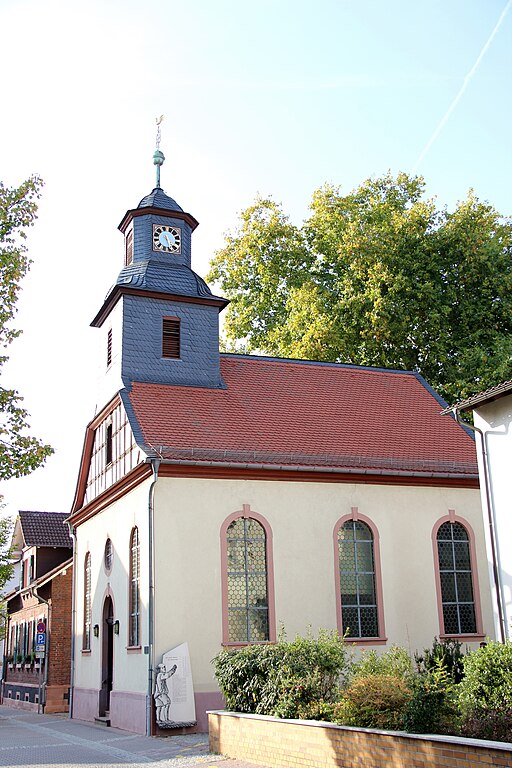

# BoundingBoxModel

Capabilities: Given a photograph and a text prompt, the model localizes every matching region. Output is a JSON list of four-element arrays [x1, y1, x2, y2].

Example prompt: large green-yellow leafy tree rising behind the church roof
[[207, 173, 512, 401]]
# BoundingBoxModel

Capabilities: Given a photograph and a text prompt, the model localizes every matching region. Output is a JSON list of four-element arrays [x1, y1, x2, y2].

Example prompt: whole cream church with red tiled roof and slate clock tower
[[70, 152, 493, 733]]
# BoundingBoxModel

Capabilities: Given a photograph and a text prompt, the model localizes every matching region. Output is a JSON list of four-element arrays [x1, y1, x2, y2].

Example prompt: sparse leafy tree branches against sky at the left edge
[[0, 176, 53, 480]]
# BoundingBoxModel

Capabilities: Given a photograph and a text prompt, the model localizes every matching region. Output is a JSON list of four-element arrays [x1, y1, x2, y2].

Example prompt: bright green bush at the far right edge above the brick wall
[[458, 642, 512, 741]]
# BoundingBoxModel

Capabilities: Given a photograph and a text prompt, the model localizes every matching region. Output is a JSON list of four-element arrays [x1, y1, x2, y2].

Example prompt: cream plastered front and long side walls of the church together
[[74, 477, 494, 733]]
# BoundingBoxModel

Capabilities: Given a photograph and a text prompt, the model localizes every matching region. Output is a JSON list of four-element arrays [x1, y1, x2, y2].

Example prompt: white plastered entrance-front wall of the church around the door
[[75, 481, 150, 693]]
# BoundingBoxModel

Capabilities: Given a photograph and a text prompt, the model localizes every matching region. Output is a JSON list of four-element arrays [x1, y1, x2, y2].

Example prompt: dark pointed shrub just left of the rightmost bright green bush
[[402, 657, 458, 734]]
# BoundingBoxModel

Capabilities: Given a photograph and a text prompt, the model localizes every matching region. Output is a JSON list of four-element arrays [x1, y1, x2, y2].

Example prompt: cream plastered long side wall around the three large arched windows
[[151, 478, 494, 692]]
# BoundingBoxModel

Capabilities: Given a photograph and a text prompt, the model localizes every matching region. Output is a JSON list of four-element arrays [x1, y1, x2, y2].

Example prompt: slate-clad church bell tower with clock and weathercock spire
[[91, 121, 228, 402]]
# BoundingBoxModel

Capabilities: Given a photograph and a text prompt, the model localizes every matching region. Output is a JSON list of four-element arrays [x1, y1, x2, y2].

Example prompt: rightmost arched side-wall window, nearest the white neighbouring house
[[434, 512, 481, 637]]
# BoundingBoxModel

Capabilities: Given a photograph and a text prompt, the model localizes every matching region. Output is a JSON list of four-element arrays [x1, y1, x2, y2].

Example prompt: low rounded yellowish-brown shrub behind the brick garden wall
[[335, 674, 411, 730]]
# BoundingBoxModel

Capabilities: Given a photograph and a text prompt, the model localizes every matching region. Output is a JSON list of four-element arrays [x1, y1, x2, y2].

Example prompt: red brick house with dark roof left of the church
[[2, 511, 73, 712]]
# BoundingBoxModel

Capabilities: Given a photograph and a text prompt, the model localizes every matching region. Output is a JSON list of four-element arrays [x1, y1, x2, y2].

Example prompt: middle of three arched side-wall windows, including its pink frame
[[334, 508, 385, 642]]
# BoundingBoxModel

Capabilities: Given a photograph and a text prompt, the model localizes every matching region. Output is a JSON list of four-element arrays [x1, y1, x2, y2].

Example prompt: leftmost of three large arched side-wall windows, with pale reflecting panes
[[221, 505, 275, 645]]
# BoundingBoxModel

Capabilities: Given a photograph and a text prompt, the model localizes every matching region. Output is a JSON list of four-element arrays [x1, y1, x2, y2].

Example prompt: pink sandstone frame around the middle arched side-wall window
[[333, 507, 387, 645]]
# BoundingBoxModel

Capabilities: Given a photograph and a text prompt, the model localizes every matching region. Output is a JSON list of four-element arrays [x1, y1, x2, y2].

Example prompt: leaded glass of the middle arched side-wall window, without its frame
[[338, 520, 379, 637]]
